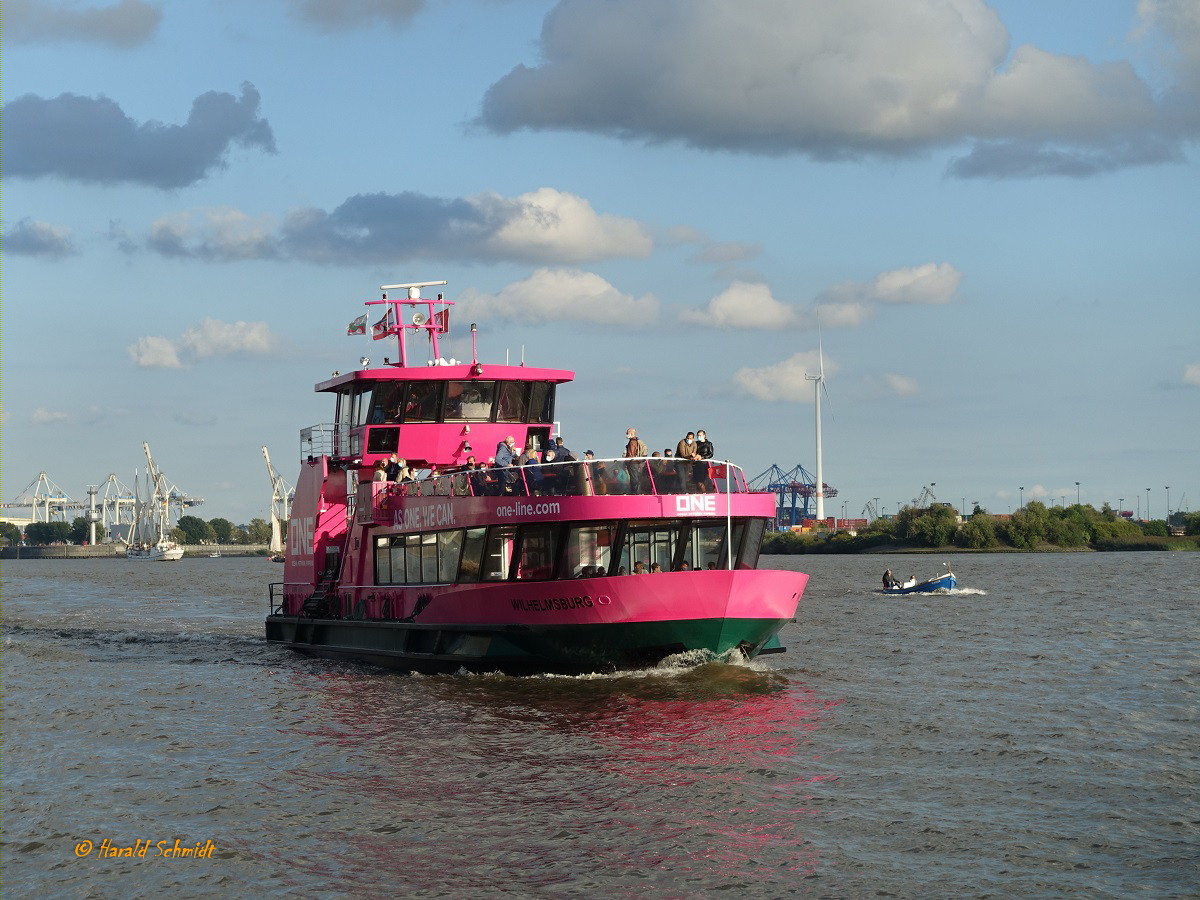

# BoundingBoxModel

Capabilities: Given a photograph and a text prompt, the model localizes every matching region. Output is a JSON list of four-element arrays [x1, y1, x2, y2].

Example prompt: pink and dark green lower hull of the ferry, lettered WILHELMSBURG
[[266, 570, 806, 674]]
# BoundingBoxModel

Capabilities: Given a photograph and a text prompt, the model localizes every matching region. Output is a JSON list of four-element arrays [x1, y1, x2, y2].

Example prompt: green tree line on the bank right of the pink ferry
[[762, 500, 1200, 553]]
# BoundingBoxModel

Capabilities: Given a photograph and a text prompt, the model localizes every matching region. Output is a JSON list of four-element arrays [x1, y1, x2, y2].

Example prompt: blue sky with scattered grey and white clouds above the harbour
[[0, 0, 1200, 522]]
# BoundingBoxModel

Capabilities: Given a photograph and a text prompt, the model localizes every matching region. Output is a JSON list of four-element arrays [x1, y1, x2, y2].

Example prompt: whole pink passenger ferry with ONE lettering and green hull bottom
[[266, 281, 808, 674]]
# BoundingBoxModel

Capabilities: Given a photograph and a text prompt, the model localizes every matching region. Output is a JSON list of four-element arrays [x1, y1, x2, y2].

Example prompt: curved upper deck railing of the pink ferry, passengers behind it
[[355, 457, 751, 524]]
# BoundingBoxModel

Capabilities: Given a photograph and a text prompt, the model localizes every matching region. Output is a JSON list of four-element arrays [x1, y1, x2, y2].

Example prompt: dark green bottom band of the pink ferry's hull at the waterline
[[266, 616, 790, 674]]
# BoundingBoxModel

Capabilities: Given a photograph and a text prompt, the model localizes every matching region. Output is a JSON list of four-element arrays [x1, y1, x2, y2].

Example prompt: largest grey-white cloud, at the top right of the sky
[[480, 0, 1200, 176]]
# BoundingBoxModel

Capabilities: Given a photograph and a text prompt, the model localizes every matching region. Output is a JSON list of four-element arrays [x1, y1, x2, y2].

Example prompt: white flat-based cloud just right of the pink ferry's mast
[[455, 269, 659, 328]]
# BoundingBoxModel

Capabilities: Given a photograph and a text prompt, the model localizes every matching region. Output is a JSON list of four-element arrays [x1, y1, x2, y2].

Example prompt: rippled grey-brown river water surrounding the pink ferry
[[2, 553, 1200, 898]]
